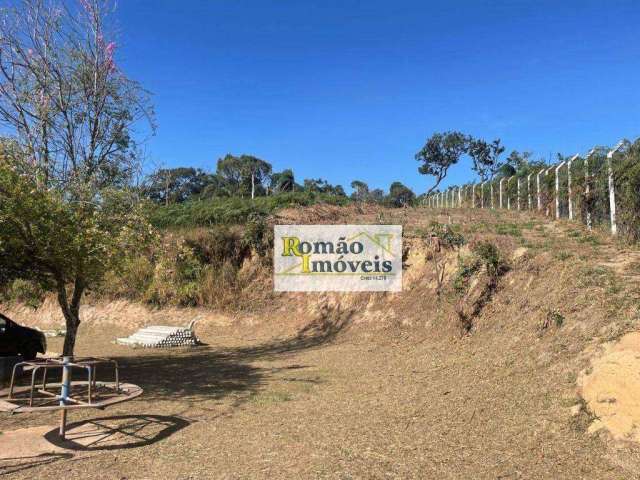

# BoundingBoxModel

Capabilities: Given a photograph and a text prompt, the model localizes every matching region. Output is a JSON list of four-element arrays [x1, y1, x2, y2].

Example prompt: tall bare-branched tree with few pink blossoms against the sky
[[0, 0, 153, 191]]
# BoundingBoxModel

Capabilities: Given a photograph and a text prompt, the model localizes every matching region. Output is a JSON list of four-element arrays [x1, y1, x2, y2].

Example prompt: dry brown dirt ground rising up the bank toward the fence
[[0, 207, 640, 480]]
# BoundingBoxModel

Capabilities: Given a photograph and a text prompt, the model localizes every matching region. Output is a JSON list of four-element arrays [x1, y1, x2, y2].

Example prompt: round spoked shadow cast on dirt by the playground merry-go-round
[[45, 415, 191, 452]]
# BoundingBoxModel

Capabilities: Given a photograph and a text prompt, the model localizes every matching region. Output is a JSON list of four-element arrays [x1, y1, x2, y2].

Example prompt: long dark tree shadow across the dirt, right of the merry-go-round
[[107, 311, 352, 405]]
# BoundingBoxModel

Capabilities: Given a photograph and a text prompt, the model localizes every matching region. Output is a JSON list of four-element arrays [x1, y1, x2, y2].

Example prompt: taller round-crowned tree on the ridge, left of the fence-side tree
[[415, 132, 469, 194]]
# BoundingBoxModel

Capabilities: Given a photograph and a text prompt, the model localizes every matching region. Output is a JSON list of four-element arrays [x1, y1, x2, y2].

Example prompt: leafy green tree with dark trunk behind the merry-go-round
[[0, 156, 154, 355]]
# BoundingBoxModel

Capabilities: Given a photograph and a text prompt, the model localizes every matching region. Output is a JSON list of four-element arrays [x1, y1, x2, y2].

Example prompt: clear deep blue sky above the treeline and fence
[[116, 0, 640, 193]]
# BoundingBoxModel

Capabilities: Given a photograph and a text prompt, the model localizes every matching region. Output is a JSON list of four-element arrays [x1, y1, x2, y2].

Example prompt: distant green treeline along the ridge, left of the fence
[[139, 155, 416, 228]]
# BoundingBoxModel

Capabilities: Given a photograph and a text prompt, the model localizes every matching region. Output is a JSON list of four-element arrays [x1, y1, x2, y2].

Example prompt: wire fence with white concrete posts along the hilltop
[[423, 139, 640, 241]]
